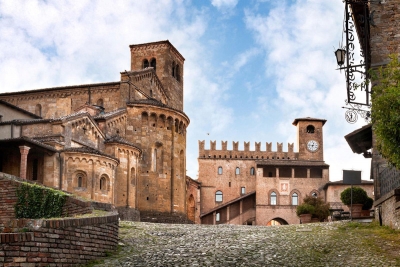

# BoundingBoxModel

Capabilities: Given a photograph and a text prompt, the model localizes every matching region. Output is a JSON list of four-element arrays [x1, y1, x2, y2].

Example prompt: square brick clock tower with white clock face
[[293, 117, 326, 161]]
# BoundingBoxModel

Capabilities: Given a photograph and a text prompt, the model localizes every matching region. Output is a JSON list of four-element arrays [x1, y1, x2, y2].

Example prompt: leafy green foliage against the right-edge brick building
[[371, 54, 400, 168]]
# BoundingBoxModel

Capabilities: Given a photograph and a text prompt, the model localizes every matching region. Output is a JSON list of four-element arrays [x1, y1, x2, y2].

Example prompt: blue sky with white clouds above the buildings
[[0, 0, 370, 181]]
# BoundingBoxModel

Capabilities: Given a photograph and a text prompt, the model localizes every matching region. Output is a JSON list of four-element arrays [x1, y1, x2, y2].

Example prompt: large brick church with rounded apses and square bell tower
[[0, 41, 189, 221]]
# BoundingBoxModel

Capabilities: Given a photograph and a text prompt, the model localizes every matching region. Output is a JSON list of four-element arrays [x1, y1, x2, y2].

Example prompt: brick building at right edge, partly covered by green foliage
[[345, 0, 400, 229]]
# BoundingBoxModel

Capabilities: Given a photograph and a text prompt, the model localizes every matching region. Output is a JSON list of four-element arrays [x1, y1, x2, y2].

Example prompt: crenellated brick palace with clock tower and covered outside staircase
[[198, 117, 329, 225]]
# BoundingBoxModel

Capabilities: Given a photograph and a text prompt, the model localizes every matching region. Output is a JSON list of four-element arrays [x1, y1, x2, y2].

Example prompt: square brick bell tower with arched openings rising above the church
[[129, 40, 185, 111]]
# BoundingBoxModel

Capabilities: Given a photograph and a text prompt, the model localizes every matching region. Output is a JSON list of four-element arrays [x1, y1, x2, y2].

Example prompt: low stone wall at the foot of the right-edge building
[[374, 189, 400, 230]]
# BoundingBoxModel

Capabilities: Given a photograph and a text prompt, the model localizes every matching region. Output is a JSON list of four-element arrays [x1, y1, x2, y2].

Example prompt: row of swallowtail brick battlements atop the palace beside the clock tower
[[199, 140, 298, 160]]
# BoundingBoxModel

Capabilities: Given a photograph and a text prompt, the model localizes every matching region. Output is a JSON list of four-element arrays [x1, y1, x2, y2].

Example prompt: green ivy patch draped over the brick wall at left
[[15, 183, 67, 219]]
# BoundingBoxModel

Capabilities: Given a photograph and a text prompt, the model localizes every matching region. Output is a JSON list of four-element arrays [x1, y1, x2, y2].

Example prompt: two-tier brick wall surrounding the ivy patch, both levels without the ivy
[[0, 173, 118, 266]]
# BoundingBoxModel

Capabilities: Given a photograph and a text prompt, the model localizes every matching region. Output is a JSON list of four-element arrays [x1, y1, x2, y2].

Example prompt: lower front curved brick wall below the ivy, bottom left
[[0, 212, 118, 266]]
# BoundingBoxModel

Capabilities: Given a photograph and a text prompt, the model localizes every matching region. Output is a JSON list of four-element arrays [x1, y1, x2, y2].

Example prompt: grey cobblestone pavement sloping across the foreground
[[95, 222, 399, 267]]
